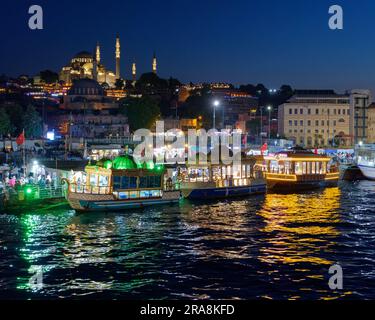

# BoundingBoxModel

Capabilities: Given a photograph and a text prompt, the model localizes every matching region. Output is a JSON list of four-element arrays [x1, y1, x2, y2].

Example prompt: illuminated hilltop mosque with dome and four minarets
[[59, 36, 157, 87]]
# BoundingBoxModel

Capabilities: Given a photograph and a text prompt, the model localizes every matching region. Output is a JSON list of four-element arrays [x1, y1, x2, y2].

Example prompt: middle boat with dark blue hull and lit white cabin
[[178, 155, 267, 200]]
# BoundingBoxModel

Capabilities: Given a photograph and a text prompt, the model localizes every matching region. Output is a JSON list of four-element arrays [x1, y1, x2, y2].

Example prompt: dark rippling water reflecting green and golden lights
[[0, 181, 375, 299]]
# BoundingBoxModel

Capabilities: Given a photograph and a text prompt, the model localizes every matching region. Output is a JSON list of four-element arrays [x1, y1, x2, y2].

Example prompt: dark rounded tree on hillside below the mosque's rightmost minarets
[[120, 96, 160, 132]]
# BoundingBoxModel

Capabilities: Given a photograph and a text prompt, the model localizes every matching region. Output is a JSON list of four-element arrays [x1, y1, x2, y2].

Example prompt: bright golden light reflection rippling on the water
[[258, 188, 341, 265]]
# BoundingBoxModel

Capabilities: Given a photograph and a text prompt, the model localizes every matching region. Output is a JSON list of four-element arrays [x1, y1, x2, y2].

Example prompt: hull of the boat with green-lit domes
[[68, 191, 181, 212]]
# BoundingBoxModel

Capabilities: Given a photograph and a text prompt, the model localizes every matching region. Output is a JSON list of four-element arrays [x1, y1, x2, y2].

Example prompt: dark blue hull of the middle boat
[[182, 183, 267, 200]]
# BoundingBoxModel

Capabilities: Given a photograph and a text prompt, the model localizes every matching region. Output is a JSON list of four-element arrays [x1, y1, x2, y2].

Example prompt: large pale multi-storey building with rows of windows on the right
[[278, 90, 353, 147]]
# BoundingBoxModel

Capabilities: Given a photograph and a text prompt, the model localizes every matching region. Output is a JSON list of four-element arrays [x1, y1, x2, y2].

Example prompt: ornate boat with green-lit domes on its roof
[[66, 156, 181, 211]]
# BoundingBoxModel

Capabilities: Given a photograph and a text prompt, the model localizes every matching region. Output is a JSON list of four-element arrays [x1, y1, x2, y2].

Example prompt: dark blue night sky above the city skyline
[[0, 0, 375, 91]]
